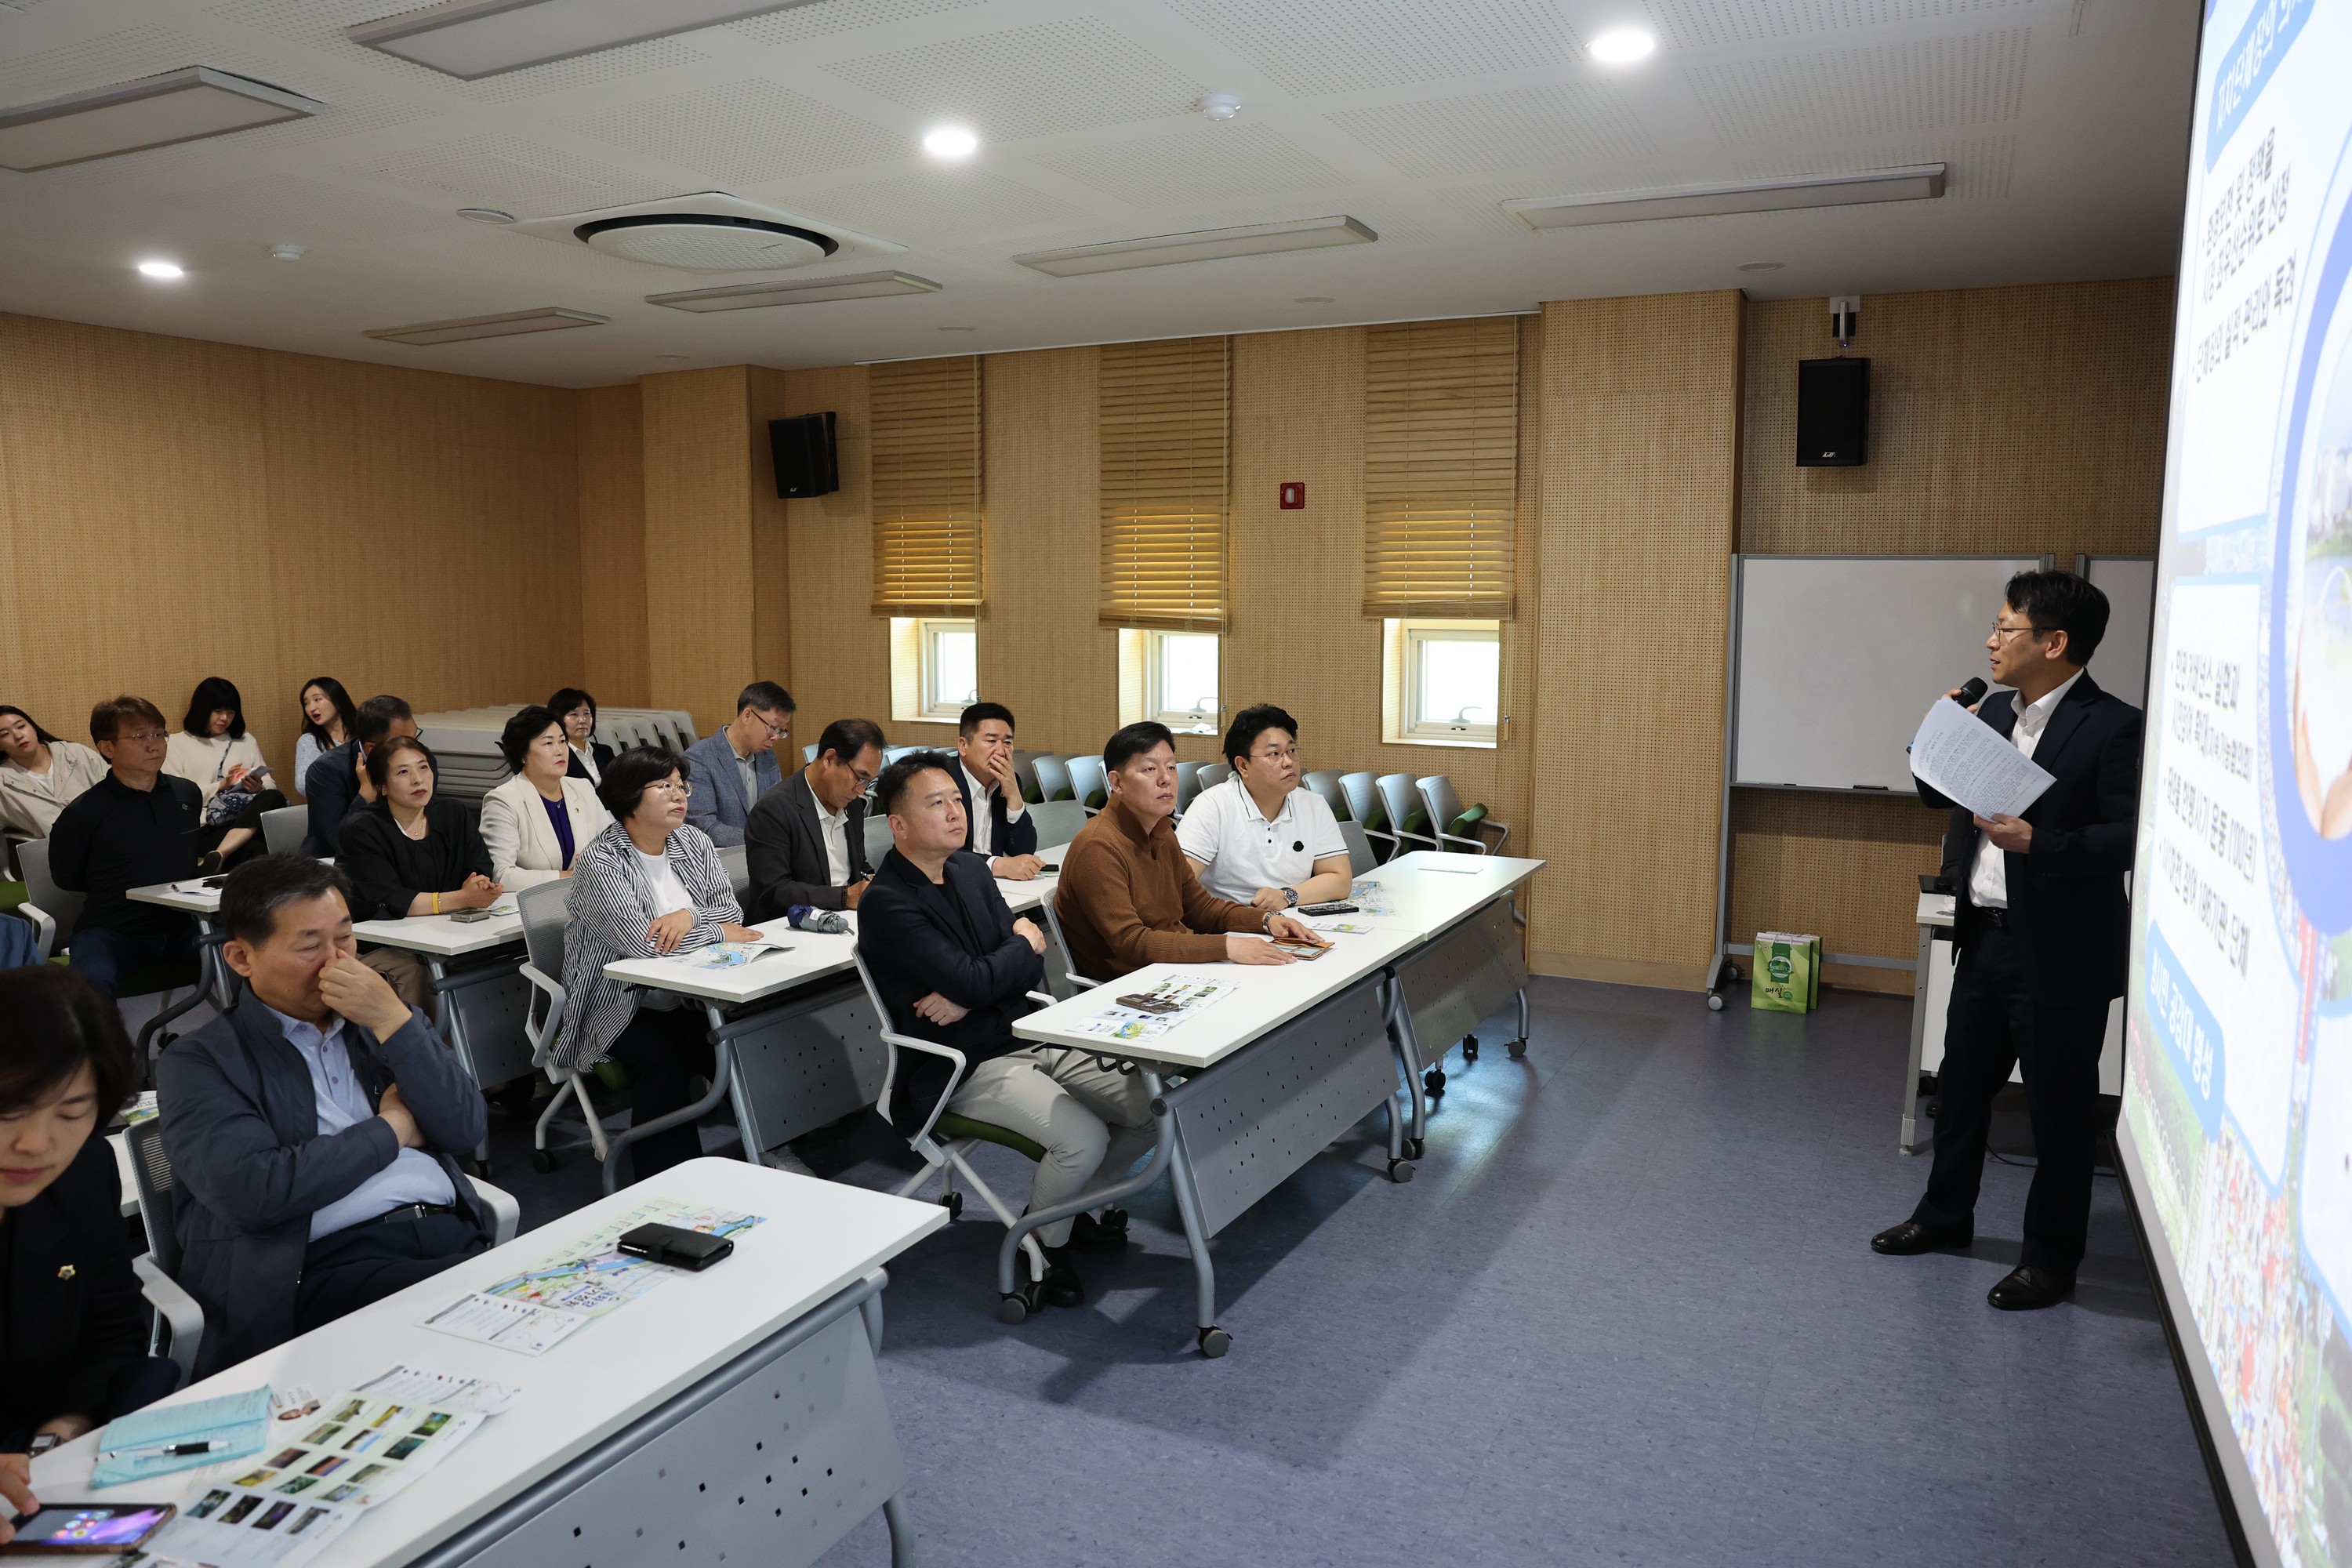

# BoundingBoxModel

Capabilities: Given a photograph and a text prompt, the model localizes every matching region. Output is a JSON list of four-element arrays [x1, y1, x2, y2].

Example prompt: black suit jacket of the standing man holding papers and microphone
[[1919, 673, 2140, 1006]]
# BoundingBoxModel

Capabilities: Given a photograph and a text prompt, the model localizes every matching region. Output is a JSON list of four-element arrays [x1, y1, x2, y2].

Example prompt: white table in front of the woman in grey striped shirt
[[588, 846, 1065, 1192]]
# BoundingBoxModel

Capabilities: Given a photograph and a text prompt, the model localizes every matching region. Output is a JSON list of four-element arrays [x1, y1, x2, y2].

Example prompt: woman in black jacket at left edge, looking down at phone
[[0, 964, 179, 1540]]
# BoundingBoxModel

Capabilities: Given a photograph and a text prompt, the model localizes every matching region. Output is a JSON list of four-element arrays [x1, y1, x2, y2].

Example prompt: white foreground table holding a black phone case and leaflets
[[33, 1159, 948, 1568]]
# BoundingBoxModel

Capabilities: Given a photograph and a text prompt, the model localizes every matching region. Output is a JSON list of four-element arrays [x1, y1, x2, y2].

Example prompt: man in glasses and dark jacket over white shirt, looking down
[[748, 720, 884, 919]]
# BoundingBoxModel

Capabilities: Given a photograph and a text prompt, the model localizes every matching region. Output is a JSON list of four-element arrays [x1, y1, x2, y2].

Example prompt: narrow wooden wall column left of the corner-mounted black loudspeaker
[[637, 365, 760, 736]]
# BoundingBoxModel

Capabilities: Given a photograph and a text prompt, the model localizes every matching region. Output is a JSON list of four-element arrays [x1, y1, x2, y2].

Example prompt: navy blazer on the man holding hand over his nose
[[155, 994, 489, 1377]]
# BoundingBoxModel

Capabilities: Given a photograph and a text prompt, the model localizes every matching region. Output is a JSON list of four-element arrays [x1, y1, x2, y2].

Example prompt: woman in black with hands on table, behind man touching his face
[[336, 736, 506, 1011]]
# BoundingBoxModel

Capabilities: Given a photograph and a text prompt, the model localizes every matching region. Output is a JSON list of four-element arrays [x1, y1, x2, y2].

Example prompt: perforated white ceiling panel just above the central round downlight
[[826, 16, 1207, 141]]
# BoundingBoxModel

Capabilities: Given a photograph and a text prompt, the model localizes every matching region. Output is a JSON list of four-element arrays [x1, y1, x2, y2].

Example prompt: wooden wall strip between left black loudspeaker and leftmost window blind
[[769, 365, 898, 760]]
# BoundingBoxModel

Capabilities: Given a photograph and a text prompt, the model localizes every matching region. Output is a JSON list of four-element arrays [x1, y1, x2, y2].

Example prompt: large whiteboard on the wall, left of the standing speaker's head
[[1731, 555, 2044, 794]]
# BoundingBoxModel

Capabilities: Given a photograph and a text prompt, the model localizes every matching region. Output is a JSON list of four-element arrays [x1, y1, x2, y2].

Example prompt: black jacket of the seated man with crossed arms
[[858, 848, 1044, 1131]]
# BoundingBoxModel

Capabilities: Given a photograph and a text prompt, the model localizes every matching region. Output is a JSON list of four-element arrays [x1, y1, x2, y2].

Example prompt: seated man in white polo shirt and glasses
[[1176, 703, 1352, 909]]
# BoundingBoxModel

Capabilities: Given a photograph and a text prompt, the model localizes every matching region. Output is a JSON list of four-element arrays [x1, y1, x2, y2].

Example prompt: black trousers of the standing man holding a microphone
[[1912, 926, 2107, 1279]]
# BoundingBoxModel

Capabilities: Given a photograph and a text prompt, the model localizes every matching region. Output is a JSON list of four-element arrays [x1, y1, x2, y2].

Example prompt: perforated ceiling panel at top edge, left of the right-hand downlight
[[1169, 0, 1583, 99]]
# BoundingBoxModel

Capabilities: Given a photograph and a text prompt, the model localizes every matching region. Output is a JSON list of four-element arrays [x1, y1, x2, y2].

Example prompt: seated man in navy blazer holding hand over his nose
[[155, 855, 489, 1375]]
